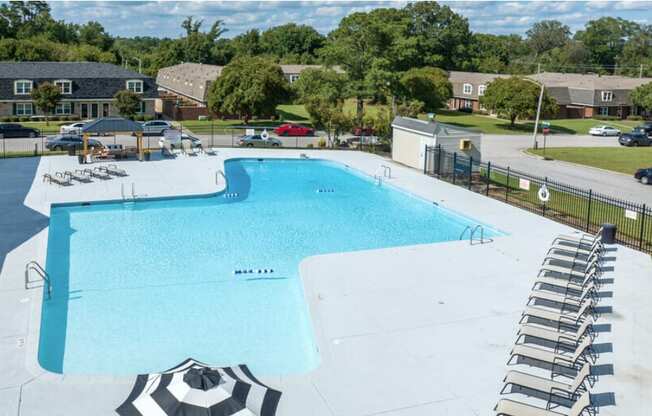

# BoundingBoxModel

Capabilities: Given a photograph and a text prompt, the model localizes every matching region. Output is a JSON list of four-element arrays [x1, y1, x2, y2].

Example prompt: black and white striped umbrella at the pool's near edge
[[116, 358, 281, 416]]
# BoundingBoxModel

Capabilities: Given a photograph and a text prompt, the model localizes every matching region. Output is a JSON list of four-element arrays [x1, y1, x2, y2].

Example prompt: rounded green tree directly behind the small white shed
[[400, 67, 453, 111]]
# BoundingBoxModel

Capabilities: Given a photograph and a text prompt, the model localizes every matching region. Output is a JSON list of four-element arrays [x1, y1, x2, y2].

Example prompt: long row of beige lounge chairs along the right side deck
[[494, 230, 604, 416]]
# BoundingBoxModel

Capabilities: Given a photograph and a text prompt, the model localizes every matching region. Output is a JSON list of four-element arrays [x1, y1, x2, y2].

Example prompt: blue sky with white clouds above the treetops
[[45, 0, 652, 37]]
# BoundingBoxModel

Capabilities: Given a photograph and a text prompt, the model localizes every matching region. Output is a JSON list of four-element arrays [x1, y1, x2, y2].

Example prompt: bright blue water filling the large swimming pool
[[39, 159, 496, 375]]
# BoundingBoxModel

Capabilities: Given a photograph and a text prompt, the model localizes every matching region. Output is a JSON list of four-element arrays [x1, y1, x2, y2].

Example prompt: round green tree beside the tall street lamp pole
[[480, 77, 557, 127]]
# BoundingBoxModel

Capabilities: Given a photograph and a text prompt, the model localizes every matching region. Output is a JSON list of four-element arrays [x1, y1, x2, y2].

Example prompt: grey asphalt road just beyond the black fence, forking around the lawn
[[482, 134, 652, 206]]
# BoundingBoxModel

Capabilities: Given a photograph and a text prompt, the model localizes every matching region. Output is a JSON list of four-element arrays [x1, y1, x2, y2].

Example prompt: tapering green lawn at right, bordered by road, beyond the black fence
[[528, 147, 652, 174]]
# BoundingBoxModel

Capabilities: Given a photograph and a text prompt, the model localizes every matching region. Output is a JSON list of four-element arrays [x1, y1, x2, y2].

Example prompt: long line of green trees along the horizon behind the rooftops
[[0, 1, 652, 78]]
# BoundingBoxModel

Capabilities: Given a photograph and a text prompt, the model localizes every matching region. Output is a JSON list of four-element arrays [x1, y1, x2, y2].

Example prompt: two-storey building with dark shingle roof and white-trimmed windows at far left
[[0, 62, 158, 119]]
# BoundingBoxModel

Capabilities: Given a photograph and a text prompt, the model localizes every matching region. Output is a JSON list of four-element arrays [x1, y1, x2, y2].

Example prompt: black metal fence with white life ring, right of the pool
[[424, 146, 652, 253]]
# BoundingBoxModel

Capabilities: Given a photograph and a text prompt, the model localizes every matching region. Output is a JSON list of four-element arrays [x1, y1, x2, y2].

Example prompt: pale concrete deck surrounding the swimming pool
[[0, 149, 652, 416]]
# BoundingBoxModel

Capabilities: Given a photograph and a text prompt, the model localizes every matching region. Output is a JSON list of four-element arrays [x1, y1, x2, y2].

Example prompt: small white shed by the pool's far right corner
[[392, 117, 482, 169]]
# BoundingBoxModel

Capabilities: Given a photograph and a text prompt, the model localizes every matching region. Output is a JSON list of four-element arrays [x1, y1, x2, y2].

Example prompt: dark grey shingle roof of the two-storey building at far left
[[0, 62, 149, 79]]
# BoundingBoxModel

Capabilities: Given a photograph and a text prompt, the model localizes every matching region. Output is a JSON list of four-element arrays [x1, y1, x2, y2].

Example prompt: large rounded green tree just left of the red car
[[208, 57, 290, 122]]
